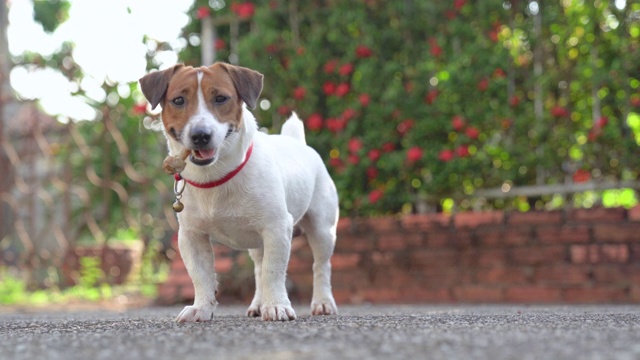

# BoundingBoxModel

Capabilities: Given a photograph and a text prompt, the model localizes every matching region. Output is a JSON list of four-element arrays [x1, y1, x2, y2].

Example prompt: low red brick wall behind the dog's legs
[[159, 206, 640, 304]]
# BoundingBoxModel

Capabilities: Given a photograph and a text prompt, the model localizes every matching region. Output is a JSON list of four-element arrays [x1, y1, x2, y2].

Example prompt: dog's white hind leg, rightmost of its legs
[[299, 213, 338, 315]]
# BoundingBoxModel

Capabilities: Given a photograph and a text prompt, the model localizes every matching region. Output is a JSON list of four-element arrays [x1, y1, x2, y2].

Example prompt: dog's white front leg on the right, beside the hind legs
[[260, 220, 296, 321]]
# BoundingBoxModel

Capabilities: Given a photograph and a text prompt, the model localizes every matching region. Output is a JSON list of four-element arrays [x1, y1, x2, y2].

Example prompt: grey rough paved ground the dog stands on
[[0, 305, 640, 360]]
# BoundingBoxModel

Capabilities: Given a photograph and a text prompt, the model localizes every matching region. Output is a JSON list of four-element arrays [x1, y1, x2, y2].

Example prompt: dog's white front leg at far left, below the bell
[[176, 228, 218, 322]]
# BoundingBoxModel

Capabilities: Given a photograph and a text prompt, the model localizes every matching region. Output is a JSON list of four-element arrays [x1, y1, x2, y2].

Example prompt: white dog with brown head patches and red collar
[[139, 62, 339, 322]]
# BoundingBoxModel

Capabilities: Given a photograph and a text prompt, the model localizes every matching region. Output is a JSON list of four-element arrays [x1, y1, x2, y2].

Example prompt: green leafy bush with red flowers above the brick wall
[[181, 0, 640, 215]]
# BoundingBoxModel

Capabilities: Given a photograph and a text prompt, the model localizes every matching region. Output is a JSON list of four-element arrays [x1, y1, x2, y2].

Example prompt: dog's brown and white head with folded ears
[[140, 63, 263, 166]]
